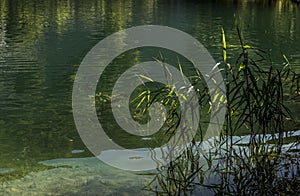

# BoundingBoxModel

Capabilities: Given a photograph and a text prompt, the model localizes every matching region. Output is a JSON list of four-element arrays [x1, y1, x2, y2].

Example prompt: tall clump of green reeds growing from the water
[[138, 29, 300, 195]]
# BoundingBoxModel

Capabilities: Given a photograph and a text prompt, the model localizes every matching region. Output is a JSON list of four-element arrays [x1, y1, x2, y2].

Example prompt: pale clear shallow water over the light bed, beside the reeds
[[0, 130, 300, 195]]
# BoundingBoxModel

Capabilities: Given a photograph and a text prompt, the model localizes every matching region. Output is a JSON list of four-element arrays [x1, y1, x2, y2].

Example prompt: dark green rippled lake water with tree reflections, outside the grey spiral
[[0, 0, 300, 192]]
